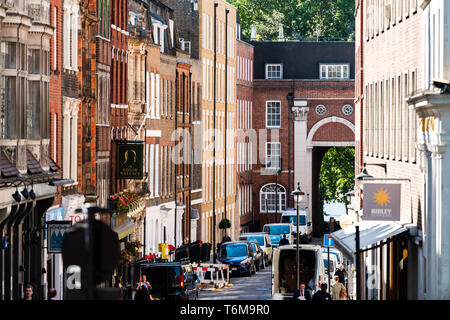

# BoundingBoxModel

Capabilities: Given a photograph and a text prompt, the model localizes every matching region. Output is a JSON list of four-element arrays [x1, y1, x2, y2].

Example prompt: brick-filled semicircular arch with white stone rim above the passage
[[306, 116, 355, 146]]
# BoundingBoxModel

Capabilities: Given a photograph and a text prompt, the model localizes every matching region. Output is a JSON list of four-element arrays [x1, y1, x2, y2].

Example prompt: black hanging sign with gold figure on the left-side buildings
[[117, 143, 144, 180]]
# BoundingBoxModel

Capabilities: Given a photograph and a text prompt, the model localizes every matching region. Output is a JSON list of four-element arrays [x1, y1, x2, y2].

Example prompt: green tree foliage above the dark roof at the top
[[228, 0, 355, 40]]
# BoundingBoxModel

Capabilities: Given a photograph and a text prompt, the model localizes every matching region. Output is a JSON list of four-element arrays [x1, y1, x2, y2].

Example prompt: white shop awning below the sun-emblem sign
[[331, 221, 408, 257]]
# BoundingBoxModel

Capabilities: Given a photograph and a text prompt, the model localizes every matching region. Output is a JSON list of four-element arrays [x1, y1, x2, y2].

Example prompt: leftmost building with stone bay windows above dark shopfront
[[0, 0, 61, 300]]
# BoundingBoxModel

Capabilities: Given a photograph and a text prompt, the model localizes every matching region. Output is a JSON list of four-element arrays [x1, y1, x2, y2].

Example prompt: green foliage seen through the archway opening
[[319, 147, 355, 204]]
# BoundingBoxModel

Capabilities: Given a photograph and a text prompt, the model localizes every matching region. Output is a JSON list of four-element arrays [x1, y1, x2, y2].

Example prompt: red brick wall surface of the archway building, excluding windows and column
[[251, 80, 354, 228]]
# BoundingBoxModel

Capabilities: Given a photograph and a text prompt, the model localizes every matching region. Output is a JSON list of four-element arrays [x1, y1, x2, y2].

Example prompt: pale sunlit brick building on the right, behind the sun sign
[[353, 1, 428, 300]]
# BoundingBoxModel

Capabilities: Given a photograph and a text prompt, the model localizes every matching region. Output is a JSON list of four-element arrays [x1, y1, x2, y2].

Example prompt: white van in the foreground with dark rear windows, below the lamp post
[[272, 244, 328, 300]]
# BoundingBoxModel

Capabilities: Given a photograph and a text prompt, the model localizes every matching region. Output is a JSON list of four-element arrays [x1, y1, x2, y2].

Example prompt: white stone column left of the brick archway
[[288, 99, 311, 206]]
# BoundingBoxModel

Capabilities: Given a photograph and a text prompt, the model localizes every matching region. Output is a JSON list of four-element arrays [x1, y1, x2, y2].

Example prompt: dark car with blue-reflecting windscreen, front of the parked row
[[218, 241, 256, 276]]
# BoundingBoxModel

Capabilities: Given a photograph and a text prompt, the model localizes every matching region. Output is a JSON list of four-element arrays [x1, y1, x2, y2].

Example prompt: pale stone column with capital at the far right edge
[[409, 93, 450, 300]]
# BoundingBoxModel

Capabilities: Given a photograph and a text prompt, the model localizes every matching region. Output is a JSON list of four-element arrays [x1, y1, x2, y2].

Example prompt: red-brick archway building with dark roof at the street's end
[[251, 42, 354, 234]]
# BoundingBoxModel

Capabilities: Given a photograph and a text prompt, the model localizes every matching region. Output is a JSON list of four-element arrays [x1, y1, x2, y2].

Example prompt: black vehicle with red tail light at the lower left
[[135, 261, 199, 300]]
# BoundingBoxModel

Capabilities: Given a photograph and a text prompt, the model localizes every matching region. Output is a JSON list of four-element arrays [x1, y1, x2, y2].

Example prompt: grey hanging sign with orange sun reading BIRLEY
[[363, 183, 401, 221]]
